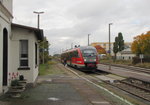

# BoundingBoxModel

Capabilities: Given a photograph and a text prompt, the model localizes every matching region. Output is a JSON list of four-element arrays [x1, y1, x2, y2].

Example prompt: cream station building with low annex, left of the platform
[[0, 0, 43, 94]]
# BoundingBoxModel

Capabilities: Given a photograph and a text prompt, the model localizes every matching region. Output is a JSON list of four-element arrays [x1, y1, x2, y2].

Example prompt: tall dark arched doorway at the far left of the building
[[3, 28, 8, 86]]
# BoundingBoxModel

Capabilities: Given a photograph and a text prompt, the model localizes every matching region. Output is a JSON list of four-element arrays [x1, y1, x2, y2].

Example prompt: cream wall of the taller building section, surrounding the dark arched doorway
[[0, 0, 13, 94]]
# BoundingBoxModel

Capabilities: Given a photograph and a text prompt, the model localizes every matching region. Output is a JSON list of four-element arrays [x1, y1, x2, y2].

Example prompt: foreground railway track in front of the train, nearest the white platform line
[[64, 65, 150, 103]]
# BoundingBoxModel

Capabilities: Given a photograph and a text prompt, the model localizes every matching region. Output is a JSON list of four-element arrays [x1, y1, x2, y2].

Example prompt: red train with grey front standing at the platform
[[61, 46, 98, 69]]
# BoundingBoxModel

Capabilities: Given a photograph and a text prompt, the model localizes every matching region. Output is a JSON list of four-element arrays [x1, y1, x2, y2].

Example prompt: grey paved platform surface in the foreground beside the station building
[[0, 64, 110, 105]]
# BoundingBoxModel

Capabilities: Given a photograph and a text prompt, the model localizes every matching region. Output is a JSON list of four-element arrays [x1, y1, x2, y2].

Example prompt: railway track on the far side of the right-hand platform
[[99, 63, 150, 74]]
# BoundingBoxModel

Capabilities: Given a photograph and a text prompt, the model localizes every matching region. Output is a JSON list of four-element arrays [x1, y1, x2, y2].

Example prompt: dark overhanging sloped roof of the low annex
[[11, 23, 44, 41]]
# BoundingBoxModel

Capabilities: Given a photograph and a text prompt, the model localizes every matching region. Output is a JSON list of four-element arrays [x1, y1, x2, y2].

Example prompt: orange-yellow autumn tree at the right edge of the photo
[[131, 31, 150, 55]]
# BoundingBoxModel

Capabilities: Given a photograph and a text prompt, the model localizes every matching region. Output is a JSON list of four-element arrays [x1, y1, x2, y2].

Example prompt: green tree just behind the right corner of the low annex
[[39, 37, 50, 63]]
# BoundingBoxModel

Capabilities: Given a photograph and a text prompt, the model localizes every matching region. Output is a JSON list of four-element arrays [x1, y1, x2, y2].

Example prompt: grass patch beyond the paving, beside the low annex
[[39, 61, 64, 75]]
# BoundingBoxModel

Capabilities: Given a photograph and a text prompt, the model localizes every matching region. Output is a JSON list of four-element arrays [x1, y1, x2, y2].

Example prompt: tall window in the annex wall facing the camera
[[20, 40, 28, 68]]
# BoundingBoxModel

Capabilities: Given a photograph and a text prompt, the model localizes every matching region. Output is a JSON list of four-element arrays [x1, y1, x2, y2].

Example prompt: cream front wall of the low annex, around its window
[[10, 28, 38, 83]]
